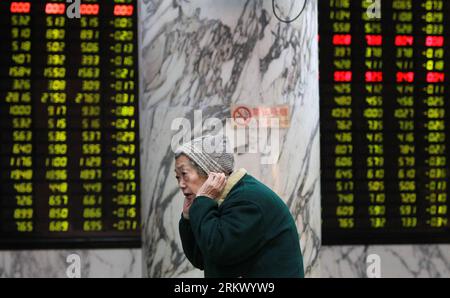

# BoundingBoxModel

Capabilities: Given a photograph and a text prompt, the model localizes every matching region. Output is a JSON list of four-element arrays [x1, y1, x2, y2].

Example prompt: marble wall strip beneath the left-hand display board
[[0, 249, 142, 278]]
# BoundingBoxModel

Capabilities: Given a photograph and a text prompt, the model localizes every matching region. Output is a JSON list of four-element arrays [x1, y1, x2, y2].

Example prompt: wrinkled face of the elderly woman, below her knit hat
[[175, 155, 207, 200]]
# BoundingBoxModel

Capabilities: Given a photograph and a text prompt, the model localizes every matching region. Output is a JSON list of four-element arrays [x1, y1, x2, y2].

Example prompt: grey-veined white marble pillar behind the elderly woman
[[139, 0, 321, 277]]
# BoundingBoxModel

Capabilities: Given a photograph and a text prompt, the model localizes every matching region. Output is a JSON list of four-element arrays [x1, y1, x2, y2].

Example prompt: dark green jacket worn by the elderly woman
[[179, 170, 304, 278]]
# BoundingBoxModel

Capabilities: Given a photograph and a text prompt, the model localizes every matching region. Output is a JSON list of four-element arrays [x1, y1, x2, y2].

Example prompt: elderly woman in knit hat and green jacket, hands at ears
[[175, 136, 304, 278]]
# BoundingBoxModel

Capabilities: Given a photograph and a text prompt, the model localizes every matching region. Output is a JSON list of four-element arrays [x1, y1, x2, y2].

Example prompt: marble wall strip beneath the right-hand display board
[[320, 245, 450, 278]]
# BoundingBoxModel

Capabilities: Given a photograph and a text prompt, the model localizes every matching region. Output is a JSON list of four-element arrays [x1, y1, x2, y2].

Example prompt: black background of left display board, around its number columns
[[0, 0, 140, 249]]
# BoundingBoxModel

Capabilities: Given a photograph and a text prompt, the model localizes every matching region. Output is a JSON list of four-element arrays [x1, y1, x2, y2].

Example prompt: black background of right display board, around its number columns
[[319, 0, 450, 245]]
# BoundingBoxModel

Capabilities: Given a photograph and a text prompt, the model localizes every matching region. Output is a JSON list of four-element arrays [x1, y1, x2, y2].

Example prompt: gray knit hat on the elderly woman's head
[[175, 135, 234, 175]]
